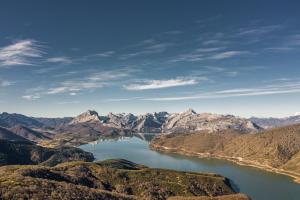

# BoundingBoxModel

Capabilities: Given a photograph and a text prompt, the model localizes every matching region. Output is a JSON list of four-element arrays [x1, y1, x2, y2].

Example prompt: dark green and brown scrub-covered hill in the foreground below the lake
[[0, 160, 248, 199]]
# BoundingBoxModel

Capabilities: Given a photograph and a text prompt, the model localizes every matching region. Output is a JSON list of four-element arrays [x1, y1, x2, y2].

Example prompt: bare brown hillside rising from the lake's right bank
[[151, 125, 300, 183]]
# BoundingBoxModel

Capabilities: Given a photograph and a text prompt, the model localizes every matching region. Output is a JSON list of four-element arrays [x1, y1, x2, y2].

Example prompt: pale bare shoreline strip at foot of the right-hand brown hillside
[[149, 144, 300, 184]]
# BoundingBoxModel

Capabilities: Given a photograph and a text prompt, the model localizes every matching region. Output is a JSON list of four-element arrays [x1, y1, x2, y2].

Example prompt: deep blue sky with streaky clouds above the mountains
[[0, 0, 300, 117]]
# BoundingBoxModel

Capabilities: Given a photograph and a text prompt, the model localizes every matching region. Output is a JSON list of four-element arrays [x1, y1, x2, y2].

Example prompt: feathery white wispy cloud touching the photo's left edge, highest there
[[0, 39, 44, 67]]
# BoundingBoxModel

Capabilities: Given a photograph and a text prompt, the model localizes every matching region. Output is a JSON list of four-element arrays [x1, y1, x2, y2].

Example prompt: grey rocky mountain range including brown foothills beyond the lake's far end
[[0, 109, 262, 146]]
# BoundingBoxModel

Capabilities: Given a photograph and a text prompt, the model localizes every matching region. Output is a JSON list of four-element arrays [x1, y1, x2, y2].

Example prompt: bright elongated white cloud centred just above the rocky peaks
[[124, 79, 198, 90]]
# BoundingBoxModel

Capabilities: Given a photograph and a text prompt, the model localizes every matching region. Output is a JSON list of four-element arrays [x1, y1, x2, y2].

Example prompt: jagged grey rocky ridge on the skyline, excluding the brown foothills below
[[0, 109, 260, 138]]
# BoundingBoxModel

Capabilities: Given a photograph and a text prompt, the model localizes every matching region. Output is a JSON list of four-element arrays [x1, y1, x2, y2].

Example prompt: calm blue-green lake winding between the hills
[[80, 137, 300, 200]]
